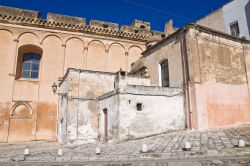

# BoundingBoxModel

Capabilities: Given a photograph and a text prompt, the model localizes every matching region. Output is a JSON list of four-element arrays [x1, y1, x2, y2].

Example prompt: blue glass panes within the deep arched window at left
[[21, 53, 41, 79]]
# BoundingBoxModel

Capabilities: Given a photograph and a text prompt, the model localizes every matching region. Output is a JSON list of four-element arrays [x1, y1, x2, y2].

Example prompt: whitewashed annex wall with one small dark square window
[[119, 94, 185, 140]]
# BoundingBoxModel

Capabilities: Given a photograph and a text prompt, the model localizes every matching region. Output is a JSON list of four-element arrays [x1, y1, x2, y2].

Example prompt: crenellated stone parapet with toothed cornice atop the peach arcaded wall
[[0, 6, 168, 42]]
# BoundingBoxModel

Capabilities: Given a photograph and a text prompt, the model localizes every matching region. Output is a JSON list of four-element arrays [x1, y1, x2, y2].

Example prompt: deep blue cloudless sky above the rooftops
[[0, 0, 229, 31]]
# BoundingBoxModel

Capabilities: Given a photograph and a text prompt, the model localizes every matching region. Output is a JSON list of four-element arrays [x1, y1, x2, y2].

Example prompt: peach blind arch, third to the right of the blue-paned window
[[87, 41, 106, 71]]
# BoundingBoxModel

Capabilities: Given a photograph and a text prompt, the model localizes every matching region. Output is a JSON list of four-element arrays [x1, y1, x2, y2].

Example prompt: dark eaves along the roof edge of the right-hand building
[[142, 23, 250, 55]]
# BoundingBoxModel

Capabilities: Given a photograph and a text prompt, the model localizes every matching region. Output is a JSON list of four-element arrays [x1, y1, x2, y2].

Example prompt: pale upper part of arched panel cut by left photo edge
[[0, 29, 16, 101]]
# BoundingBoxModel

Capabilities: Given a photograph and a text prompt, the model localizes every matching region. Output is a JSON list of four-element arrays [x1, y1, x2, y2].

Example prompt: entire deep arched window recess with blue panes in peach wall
[[16, 44, 43, 79]]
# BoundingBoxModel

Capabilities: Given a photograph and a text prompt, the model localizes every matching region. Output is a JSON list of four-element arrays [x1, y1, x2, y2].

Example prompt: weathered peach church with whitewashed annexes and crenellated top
[[0, 6, 250, 143]]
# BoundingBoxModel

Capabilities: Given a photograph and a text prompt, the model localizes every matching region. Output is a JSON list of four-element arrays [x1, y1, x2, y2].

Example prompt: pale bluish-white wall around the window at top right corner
[[222, 0, 250, 39]]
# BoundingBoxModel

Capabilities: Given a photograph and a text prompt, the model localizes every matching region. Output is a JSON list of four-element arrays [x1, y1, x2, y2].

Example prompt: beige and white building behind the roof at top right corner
[[196, 0, 250, 39]]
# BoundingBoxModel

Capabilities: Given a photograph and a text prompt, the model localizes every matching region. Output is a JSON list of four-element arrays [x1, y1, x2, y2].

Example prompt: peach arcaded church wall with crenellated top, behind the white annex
[[0, 6, 161, 142]]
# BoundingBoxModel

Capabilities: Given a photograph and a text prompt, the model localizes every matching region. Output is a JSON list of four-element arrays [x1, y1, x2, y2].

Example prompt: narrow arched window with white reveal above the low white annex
[[159, 59, 170, 87]]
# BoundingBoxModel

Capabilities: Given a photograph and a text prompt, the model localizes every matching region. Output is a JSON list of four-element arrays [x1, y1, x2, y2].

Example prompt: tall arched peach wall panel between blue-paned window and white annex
[[36, 35, 61, 140]]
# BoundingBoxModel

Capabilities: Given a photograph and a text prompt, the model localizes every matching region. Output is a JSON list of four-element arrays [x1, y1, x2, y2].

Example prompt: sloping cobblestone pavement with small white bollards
[[0, 125, 250, 166]]
